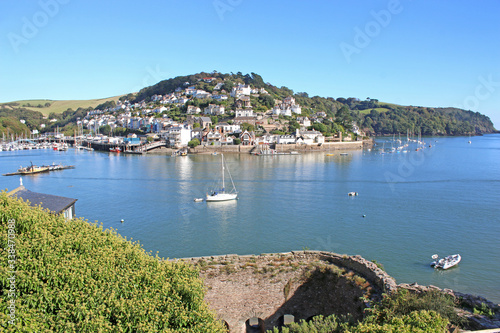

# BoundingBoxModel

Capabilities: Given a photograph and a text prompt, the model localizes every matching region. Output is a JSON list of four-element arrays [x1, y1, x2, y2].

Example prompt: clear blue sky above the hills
[[0, 0, 500, 129]]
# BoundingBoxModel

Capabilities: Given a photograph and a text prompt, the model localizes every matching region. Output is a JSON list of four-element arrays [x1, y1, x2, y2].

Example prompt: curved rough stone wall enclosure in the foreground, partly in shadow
[[178, 251, 397, 332]]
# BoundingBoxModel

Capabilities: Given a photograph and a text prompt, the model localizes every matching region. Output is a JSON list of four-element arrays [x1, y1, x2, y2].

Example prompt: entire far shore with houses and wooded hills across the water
[[0, 71, 496, 148]]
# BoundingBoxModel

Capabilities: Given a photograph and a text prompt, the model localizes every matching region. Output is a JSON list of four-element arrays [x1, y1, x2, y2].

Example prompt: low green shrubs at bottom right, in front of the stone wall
[[273, 290, 454, 333]]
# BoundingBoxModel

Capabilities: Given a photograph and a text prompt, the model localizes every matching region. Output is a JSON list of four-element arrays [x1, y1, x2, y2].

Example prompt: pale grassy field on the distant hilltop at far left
[[0, 96, 121, 116]]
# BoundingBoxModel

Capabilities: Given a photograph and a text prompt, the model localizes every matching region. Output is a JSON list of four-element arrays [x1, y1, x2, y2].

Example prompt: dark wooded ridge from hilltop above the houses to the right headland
[[136, 72, 497, 135]]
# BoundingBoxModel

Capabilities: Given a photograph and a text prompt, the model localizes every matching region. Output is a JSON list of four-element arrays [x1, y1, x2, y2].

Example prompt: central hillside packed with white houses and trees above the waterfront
[[68, 73, 364, 148]]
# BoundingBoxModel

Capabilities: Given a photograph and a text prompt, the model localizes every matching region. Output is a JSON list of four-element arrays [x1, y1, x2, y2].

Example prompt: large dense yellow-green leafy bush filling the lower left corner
[[0, 193, 225, 332]]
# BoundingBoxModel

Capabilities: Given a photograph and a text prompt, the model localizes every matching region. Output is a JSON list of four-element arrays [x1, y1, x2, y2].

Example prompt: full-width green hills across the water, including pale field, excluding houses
[[0, 72, 497, 136]]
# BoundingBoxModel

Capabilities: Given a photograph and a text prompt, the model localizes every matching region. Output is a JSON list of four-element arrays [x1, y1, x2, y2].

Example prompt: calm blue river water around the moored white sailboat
[[0, 135, 500, 302]]
